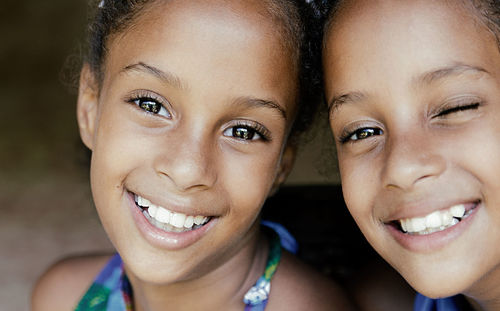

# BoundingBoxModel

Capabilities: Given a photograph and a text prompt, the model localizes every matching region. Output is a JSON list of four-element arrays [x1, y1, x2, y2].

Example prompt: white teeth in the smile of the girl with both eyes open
[[134, 194, 211, 232]]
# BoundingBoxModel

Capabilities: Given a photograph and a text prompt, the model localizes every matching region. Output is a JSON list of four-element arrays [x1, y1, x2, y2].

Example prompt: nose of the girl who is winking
[[382, 133, 446, 191]]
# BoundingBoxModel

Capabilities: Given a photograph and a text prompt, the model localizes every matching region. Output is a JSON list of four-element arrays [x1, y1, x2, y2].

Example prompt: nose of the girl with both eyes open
[[155, 135, 217, 192]]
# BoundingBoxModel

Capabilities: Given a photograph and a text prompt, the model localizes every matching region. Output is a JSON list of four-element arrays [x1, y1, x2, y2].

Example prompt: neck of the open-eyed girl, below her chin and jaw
[[127, 226, 268, 311]]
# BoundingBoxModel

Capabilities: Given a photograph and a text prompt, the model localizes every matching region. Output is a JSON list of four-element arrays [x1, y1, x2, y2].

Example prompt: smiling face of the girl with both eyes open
[[78, 0, 296, 283]]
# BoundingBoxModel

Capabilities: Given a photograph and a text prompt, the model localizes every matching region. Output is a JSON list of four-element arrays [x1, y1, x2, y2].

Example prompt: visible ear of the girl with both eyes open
[[76, 64, 99, 150]]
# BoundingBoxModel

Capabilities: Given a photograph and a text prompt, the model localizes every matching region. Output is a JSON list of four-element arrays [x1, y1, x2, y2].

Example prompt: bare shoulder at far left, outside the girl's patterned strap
[[31, 255, 111, 311]]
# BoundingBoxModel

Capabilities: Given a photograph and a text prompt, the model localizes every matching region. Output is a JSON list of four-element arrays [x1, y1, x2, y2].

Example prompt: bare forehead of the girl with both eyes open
[[100, 0, 297, 119]]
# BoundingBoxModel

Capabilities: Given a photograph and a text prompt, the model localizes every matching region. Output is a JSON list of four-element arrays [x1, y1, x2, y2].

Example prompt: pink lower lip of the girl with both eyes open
[[127, 192, 217, 250]]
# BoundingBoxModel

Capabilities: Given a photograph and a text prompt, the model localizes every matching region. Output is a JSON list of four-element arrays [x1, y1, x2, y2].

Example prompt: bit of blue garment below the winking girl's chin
[[413, 294, 473, 311]]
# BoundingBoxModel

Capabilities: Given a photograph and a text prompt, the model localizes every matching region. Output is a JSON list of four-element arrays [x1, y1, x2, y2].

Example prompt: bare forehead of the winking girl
[[324, 0, 500, 88]]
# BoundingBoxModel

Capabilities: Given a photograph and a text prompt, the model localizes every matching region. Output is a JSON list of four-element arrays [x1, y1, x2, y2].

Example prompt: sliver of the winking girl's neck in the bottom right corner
[[465, 267, 500, 311]]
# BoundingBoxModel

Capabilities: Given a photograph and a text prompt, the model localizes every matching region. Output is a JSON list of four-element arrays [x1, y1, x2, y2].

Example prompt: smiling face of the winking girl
[[324, 0, 500, 298]]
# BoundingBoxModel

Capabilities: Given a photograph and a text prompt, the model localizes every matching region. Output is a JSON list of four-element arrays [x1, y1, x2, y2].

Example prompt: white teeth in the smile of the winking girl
[[391, 201, 480, 235]]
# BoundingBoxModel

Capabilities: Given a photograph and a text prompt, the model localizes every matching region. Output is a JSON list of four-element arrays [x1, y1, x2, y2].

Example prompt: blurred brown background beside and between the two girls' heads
[[0, 0, 338, 310]]
